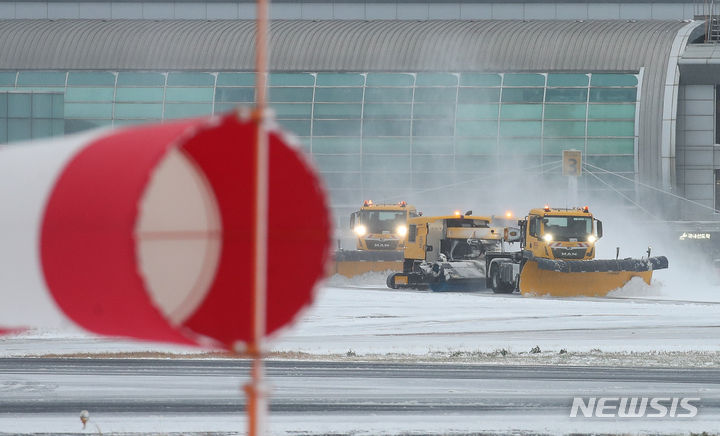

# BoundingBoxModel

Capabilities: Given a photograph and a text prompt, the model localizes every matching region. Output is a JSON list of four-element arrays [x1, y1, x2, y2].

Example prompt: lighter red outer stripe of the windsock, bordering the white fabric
[[40, 120, 201, 343]]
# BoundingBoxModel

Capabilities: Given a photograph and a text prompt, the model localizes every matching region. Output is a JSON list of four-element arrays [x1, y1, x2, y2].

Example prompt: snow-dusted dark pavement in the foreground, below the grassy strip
[[0, 359, 720, 435]]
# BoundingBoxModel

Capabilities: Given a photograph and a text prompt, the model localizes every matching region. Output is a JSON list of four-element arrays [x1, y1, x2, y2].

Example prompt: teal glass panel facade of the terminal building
[[0, 71, 640, 223]]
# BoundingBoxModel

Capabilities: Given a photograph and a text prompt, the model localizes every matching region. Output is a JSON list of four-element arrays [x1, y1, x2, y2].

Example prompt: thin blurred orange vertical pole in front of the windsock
[[247, 0, 270, 436]]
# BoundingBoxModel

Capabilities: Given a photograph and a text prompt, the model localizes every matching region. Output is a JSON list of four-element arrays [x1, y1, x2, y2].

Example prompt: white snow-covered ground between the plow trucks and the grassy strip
[[0, 273, 720, 364]]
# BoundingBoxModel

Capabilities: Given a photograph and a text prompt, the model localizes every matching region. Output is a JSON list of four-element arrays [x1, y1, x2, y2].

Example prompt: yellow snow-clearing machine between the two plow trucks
[[387, 211, 510, 291]]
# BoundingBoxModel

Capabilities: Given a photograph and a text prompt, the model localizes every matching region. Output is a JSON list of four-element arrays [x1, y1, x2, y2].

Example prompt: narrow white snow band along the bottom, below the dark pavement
[[0, 411, 720, 436]]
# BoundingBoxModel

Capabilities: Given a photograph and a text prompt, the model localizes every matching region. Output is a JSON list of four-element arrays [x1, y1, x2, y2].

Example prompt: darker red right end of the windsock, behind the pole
[[182, 116, 330, 346]]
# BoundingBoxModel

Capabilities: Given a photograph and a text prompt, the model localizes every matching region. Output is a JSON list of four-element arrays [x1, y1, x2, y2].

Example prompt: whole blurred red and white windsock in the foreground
[[0, 113, 330, 347]]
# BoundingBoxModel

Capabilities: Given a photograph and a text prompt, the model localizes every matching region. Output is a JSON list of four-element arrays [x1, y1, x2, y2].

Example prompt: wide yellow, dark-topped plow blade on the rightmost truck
[[520, 256, 668, 297]]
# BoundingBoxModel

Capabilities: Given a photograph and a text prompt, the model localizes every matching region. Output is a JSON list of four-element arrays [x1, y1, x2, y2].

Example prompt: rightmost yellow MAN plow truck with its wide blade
[[485, 206, 668, 296]]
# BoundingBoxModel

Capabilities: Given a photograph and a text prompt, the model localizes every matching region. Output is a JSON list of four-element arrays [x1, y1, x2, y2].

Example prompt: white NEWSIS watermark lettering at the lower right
[[570, 397, 700, 418]]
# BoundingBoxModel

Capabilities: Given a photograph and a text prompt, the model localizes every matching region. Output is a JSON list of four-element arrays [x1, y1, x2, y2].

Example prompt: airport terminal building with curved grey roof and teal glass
[[0, 0, 720, 225]]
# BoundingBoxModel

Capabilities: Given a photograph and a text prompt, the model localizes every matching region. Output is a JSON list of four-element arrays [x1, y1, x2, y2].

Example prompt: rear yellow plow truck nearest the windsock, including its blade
[[332, 200, 420, 277]]
